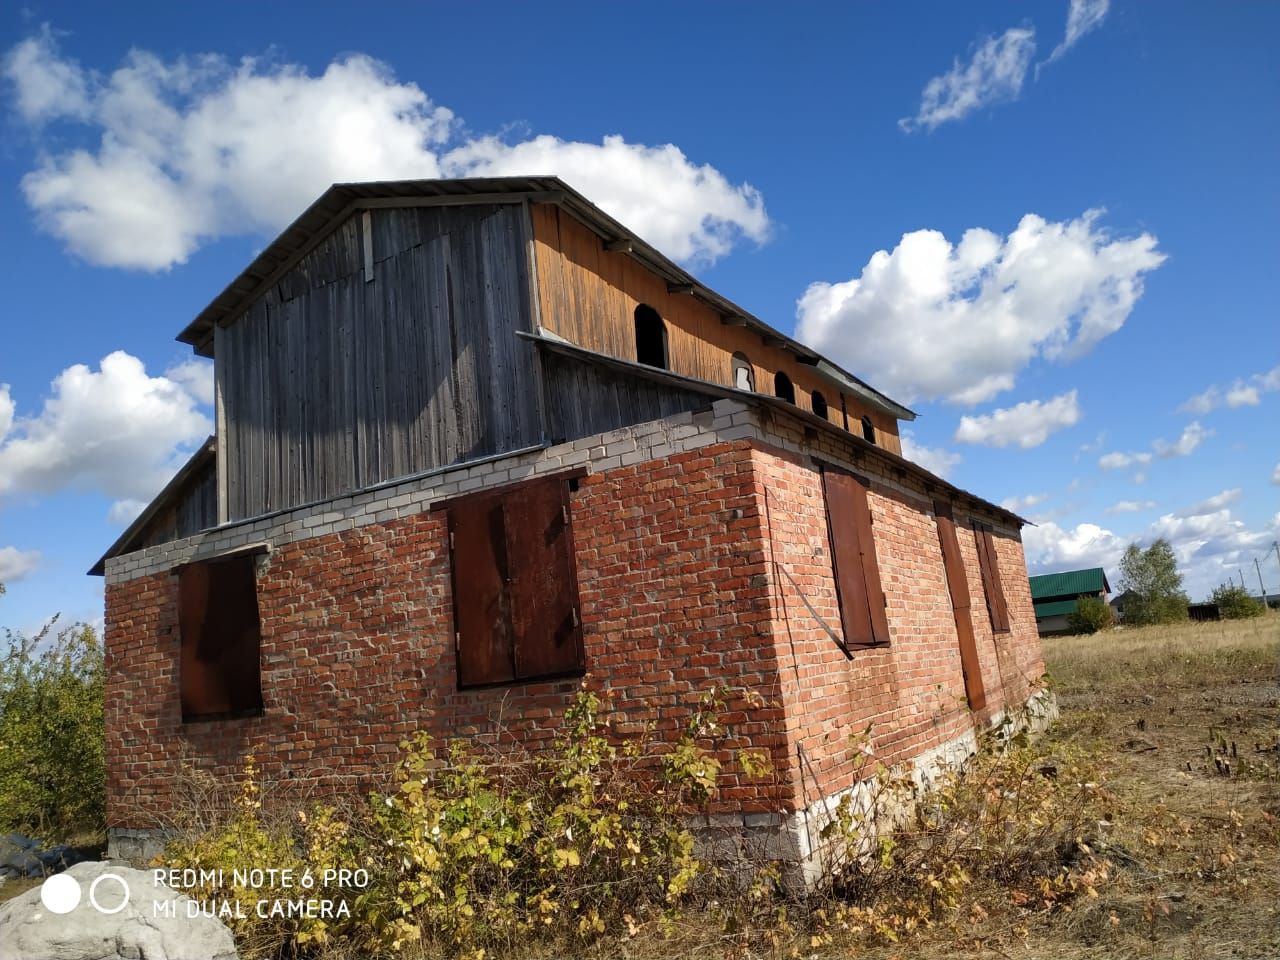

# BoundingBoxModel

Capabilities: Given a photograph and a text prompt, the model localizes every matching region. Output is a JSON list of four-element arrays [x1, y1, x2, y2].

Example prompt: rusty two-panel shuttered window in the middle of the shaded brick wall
[[449, 479, 586, 687]]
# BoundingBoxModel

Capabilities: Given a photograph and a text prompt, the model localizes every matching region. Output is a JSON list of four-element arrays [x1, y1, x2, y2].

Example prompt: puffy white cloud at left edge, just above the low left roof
[[0, 351, 212, 519]]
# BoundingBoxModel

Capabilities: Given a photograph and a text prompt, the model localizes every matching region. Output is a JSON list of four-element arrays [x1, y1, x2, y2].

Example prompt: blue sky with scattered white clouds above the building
[[0, 0, 1280, 630]]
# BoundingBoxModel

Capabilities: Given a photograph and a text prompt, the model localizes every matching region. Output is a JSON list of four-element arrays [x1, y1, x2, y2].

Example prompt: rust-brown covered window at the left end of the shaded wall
[[178, 556, 262, 721]]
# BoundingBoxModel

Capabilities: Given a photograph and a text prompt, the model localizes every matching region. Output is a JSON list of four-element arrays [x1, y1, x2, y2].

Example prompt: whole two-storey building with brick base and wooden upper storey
[[93, 178, 1043, 880]]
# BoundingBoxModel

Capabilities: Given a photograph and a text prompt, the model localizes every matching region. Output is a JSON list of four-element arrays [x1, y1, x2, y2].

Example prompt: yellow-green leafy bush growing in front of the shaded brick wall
[[157, 689, 719, 957]]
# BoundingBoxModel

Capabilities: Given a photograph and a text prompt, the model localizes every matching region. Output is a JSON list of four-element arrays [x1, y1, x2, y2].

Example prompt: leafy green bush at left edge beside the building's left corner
[[0, 623, 106, 840]]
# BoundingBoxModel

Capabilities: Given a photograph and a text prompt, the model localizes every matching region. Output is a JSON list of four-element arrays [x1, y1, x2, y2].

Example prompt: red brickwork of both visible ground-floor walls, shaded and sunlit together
[[106, 440, 1043, 827]]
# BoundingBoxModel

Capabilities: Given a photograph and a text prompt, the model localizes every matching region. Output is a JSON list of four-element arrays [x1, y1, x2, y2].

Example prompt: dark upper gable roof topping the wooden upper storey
[[178, 177, 915, 420]]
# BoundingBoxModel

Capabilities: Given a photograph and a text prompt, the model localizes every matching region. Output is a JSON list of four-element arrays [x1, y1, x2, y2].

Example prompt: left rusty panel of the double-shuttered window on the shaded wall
[[449, 497, 516, 687]]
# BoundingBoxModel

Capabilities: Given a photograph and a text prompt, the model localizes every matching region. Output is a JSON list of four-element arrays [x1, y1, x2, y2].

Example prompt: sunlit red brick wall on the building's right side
[[755, 449, 1043, 804]]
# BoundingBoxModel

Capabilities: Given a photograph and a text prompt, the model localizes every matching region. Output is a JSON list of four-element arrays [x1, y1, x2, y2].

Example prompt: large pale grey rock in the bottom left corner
[[0, 861, 237, 960]]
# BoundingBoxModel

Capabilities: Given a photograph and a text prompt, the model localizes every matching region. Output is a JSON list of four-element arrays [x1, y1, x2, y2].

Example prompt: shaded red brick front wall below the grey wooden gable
[[106, 442, 787, 827]]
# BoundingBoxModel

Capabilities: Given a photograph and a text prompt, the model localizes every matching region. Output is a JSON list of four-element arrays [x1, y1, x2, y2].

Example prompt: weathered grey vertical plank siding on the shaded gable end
[[215, 204, 541, 520]]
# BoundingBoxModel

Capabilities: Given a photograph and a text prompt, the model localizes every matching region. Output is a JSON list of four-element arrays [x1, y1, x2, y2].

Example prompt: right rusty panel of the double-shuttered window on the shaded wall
[[503, 480, 585, 678]]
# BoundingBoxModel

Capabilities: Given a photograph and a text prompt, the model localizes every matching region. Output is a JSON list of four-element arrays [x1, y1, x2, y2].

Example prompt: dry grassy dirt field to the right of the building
[[997, 613, 1280, 960]]
